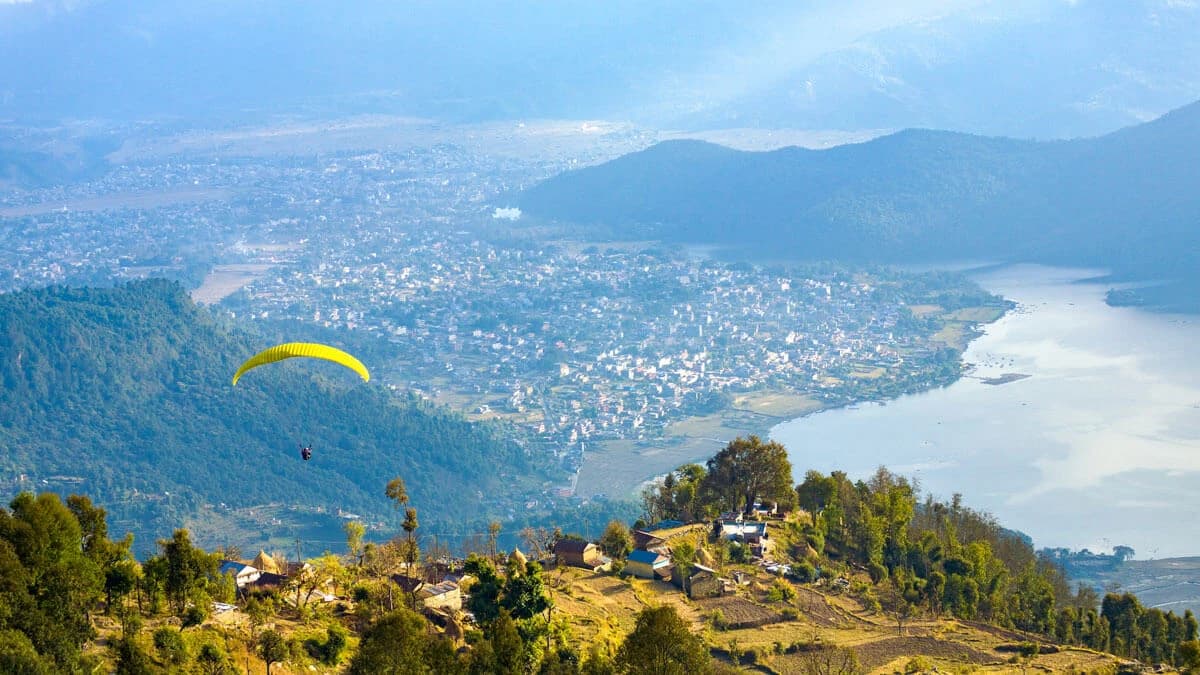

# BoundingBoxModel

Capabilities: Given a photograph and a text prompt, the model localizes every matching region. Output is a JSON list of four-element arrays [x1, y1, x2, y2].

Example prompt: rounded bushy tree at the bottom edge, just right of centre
[[617, 605, 709, 675]]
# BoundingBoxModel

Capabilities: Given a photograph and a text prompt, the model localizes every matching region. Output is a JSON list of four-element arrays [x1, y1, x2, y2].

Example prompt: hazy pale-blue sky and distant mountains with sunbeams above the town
[[0, 0, 1200, 136]]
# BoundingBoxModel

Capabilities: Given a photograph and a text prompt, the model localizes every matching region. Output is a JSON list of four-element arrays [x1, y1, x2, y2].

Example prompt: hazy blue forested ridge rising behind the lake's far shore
[[520, 97, 1200, 291]]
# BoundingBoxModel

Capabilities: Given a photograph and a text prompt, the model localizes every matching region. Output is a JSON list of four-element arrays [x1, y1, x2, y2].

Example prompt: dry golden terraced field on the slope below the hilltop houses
[[550, 550, 1118, 674]]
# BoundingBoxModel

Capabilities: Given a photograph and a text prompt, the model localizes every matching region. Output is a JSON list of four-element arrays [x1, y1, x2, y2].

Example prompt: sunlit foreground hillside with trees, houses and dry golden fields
[[0, 437, 1200, 675]]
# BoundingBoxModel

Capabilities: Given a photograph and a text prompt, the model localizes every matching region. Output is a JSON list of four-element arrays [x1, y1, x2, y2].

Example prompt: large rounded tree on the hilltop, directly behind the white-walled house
[[702, 436, 796, 513]]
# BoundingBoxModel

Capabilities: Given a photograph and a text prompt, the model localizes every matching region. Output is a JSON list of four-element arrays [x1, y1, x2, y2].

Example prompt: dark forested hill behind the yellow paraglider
[[0, 280, 536, 546]]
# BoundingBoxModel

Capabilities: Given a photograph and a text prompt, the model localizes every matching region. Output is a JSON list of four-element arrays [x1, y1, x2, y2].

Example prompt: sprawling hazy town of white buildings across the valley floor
[[0, 135, 993, 482]]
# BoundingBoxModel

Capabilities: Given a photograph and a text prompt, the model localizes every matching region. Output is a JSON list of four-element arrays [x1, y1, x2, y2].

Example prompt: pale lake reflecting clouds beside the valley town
[[770, 265, 1200, 558]]
